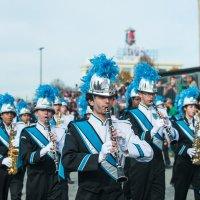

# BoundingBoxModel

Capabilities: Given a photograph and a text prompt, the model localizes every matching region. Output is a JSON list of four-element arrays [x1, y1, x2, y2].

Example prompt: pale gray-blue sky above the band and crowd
[[0, 0, 198, 98]]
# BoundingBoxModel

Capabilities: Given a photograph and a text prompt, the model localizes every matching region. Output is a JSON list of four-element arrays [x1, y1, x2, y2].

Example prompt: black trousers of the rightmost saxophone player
[[174, 156, 200, 200]]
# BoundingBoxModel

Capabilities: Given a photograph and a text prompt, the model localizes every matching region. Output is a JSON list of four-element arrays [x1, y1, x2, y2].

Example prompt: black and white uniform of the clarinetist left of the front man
[[20, 122, 65, 200]]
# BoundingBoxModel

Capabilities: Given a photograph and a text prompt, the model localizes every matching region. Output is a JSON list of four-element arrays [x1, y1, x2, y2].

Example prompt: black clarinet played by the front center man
[[105, 108, 128, 183]]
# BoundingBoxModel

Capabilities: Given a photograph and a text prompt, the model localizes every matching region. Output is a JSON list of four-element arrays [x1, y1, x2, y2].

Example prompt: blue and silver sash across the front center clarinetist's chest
[[73, 121, 116, 179]]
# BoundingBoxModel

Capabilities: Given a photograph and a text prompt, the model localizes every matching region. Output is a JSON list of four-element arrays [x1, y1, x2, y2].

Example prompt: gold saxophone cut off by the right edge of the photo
[[192, 112, 200, 165]]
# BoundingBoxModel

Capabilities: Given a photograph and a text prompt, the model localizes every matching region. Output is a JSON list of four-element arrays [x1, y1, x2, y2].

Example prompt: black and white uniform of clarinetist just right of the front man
[[123, 103, 177, 200]]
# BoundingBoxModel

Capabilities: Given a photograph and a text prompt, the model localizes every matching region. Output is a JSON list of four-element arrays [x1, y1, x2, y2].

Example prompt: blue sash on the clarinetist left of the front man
[[26, 126, 54, 159]]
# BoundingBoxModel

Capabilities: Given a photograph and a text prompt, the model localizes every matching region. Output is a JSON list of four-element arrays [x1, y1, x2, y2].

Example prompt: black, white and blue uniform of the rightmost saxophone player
[[173, 118, 200, 200]]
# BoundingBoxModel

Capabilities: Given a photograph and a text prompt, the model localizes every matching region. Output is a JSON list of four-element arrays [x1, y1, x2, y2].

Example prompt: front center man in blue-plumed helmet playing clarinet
[[62, 54, 153, 200]]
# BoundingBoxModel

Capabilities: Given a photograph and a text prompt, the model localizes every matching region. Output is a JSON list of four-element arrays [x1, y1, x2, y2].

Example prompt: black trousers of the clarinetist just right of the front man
[[124, 156, 165, 200]]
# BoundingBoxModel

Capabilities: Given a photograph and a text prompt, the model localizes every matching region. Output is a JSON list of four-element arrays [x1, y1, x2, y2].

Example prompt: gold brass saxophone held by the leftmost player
[[8, 125, 19, 175]]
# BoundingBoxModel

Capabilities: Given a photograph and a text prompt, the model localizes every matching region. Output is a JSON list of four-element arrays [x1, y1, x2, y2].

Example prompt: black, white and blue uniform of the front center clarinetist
[[62, 114, 153, 200]]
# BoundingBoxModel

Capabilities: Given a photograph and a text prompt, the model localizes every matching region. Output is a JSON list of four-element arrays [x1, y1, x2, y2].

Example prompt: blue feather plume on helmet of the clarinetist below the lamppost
[[35, 84, 55, 102]]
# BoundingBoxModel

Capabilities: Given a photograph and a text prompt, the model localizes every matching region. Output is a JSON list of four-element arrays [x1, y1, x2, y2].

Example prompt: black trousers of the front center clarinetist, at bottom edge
[[75, 187, 125, 200]]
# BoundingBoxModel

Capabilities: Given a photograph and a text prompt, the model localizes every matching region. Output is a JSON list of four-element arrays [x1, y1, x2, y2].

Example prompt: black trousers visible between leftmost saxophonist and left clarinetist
[[10, 169, 26, 200]]
